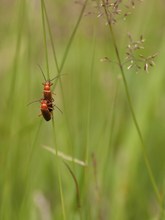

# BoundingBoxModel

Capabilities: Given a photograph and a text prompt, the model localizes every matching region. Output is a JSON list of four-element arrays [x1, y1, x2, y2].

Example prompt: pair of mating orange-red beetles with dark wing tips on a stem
[[30, 66, 62, 121]]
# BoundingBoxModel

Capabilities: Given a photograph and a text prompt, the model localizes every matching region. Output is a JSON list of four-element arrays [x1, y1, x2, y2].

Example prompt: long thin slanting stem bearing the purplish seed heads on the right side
[[102, 0, 162, 208]]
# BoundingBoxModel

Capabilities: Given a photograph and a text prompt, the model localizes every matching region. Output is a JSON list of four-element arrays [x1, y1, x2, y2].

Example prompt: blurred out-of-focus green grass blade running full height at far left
[[0, 0, 26, 219]]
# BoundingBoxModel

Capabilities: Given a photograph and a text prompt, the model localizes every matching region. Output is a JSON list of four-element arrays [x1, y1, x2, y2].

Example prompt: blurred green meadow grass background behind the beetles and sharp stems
[[0, 0, 165, 220]]
